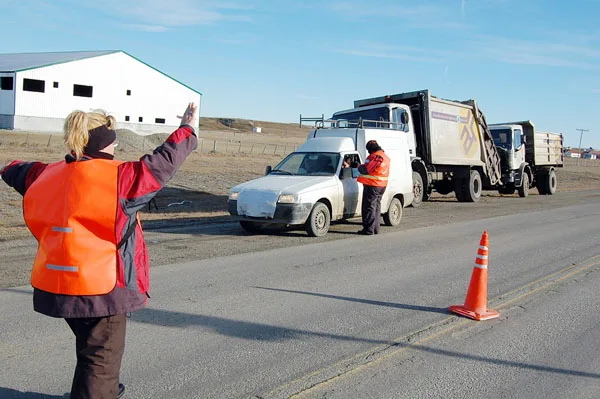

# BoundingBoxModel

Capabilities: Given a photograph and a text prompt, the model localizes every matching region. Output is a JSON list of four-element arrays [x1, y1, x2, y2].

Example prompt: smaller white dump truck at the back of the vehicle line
[[489, 121, 564, 197]]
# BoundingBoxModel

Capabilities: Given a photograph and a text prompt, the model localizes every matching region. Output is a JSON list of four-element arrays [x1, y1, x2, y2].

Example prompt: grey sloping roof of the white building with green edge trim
[[0, 50, 202, 95]]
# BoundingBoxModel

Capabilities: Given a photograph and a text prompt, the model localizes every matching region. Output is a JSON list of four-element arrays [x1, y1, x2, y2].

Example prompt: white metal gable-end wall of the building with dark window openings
[[15, 52, 200, 132]]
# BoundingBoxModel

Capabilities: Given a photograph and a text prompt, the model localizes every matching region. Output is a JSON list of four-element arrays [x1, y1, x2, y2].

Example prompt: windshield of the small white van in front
[[270, 152, 340, 176]]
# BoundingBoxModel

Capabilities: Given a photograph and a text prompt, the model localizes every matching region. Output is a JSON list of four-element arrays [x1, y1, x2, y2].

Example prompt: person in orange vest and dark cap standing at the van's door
[[357, 140, 390, 235]]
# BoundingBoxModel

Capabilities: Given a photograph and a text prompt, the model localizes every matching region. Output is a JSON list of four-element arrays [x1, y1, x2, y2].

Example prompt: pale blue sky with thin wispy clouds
[[0, 0, 600, 148]]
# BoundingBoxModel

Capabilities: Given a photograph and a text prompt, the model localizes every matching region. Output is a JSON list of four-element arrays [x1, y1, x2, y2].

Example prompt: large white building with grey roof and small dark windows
[[0, 51, 202, 134]]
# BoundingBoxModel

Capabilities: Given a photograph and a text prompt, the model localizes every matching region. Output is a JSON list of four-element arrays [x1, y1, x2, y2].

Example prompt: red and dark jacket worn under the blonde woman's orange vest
[[2, 125, 198, 318]]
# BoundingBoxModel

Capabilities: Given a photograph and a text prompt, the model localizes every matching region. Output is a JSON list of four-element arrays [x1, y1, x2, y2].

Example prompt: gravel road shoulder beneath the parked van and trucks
[[0, 190, 600, 288]]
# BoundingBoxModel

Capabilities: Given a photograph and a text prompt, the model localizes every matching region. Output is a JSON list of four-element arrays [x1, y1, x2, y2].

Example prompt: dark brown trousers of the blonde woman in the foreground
[[65, 314, 127, 399]]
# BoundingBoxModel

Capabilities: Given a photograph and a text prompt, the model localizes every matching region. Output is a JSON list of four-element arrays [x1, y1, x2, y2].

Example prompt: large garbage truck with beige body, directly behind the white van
[[340, 90, 502, 206]]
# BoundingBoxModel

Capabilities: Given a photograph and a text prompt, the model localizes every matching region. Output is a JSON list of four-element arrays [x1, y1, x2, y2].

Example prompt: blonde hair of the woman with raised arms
[[63, 110, 117, 159]]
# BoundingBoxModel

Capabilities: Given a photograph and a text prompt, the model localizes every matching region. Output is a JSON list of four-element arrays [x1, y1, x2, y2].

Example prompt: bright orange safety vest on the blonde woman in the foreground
[[23, 159, 122, 295]]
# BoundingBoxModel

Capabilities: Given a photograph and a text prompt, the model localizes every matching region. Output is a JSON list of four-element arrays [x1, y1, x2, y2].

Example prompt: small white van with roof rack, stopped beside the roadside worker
[[227, 124, 413, 237]]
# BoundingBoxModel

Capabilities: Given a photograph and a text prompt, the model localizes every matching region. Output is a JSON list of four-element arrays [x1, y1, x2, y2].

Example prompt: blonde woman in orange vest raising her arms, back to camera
[[0, 103, 198, 399]]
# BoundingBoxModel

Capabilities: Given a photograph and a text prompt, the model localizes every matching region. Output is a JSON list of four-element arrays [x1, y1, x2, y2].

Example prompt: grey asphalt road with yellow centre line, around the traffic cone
[[0, 195, 600, 399]]
